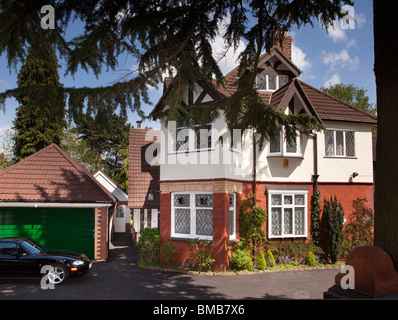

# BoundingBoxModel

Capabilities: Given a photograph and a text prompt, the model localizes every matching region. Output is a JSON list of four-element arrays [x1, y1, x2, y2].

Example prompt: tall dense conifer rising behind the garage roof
[[13, 42, 66, 161]]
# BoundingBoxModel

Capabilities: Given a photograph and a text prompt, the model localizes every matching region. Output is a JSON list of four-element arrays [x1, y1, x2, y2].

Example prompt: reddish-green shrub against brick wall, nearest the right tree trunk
[[342, 198, 374, 257]]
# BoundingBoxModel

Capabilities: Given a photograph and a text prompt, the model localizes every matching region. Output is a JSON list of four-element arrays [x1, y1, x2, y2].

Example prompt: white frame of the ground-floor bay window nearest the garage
[[171, 191, 214, 240]]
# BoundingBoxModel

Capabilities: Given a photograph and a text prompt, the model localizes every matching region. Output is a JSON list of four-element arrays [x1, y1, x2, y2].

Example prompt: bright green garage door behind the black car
[[0, 208, 94, 259]]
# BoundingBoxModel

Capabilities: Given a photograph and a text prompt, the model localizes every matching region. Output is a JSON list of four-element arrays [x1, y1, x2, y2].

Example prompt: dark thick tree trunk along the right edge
[[373, 0, 398, 270]]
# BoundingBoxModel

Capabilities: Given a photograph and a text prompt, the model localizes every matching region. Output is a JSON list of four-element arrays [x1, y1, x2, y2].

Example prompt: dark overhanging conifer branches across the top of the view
[[0, 0, 353, 139]]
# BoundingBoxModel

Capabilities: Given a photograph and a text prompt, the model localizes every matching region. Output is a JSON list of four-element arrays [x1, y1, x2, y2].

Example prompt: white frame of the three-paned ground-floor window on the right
[[268, 190, 308, 239]]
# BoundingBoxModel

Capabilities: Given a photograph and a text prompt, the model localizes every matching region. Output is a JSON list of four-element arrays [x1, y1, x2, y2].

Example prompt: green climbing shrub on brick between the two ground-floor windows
[[239, 195, 266, 257]]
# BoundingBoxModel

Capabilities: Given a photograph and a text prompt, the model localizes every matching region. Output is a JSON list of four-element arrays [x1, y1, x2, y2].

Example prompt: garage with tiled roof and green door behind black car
[[0, 144, 116, 261]]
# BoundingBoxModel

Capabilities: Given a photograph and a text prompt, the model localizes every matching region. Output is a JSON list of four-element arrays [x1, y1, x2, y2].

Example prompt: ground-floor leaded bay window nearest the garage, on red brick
[[171, 192, 213, 240]]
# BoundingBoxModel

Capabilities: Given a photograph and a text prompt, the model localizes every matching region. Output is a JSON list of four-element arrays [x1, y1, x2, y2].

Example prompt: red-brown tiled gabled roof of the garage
[[0, 144, 116, 203]]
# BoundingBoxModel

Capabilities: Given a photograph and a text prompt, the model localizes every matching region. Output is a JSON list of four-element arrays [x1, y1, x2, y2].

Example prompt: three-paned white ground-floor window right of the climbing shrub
[[268, 190, 308, 238]]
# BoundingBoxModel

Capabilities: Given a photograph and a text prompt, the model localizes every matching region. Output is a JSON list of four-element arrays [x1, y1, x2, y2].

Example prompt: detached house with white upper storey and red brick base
[[147, 36, 377, 270]]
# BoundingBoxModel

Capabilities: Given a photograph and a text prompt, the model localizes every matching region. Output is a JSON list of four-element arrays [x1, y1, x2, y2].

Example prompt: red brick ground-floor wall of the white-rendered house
[[159, 181, 374, 271]]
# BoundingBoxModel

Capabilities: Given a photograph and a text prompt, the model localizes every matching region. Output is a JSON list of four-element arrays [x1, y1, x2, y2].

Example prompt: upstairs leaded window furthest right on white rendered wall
[[325, 130, 355, 158]]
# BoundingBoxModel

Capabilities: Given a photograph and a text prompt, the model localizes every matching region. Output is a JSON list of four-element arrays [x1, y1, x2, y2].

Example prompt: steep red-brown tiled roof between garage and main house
[[129, 128, 160, 209]]
